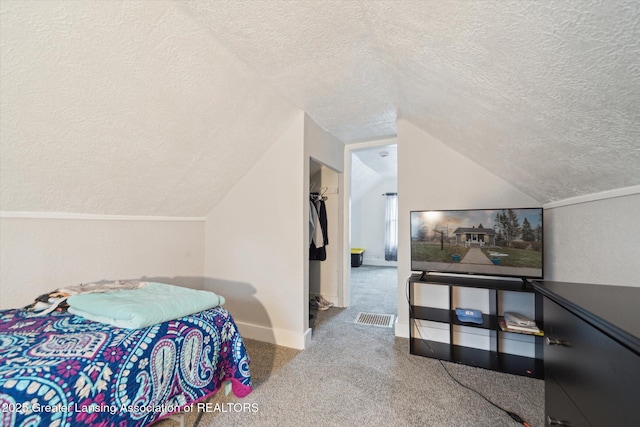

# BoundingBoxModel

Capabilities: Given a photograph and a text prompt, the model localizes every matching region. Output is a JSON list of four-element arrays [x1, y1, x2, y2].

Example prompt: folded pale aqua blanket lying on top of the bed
[[67, 282, 225, 329]]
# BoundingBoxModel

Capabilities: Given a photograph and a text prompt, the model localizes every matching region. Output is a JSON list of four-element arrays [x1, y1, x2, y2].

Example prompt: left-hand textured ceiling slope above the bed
[[0, 0, 299, 216]]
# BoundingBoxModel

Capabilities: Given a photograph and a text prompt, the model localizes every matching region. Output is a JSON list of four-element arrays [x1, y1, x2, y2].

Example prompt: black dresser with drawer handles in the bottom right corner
[[533, 281, 640, 427]]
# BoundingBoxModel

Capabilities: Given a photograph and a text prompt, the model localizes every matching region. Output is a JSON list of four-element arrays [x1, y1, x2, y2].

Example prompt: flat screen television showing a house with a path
[[411, 208, 544, 279]]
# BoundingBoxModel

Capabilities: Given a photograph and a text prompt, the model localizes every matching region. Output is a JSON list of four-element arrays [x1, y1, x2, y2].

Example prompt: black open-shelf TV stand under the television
[[409, 272, 544, 379]]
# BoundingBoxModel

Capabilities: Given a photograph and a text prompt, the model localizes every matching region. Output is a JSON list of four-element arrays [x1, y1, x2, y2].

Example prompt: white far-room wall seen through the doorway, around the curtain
[[351, 178, 398, 266]]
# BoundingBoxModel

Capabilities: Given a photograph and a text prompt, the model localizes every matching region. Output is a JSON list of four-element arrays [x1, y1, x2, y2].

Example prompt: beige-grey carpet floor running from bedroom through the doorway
[[157, 267, 544, 427]]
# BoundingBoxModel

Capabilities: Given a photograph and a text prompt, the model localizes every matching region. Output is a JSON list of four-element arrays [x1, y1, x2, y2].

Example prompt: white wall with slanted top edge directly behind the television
[[396, 119, 539, 337]]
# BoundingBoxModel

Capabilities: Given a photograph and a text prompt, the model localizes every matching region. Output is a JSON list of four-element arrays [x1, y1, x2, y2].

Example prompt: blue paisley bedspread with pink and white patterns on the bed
[[0, 307, 251, 427]]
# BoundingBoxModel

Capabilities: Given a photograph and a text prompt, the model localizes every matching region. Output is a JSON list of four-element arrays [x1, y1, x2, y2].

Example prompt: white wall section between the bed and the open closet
[[204, 112, 309, 348]]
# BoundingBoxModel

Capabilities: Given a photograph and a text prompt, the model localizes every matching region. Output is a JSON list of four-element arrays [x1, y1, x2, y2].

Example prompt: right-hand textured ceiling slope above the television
[[180, 0, 640, 203]]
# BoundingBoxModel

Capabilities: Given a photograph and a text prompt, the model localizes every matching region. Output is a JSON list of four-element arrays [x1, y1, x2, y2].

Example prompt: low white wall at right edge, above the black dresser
[[544, 186, 640, 286]]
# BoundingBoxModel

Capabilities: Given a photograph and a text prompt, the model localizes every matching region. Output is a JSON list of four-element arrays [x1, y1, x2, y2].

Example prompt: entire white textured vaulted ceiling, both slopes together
[[0, 0, 640, 216]]
